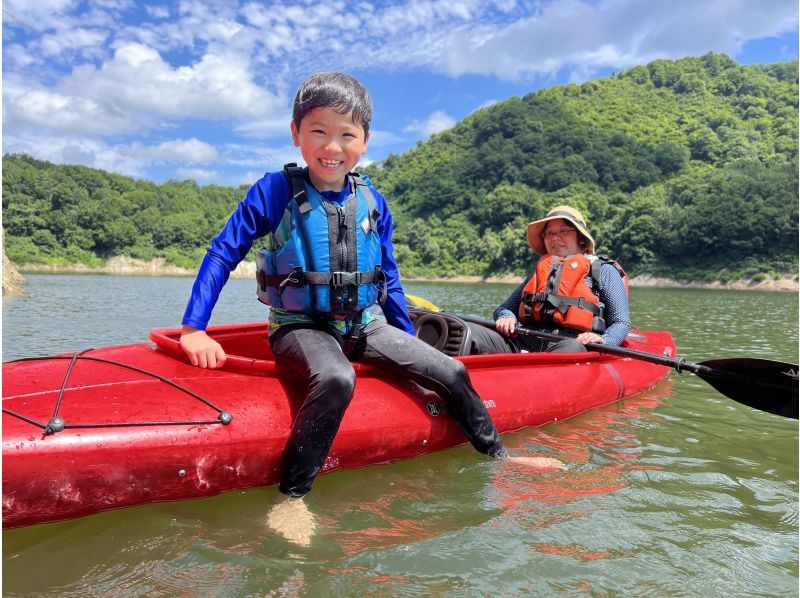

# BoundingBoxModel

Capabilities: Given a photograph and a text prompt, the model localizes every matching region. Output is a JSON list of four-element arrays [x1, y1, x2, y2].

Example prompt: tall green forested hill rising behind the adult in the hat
[[365, 54, 798, 278]]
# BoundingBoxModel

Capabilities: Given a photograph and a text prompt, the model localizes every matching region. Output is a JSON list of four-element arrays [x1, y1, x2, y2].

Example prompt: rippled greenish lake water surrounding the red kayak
[[2, 275, 798, 597]]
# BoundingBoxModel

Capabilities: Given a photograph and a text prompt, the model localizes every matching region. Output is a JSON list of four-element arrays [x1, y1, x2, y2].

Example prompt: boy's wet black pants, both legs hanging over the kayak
[[270, 320, 505, 496]]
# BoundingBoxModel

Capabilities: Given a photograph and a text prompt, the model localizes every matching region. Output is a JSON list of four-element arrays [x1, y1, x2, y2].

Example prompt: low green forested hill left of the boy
[[3, 154, 247, 268]]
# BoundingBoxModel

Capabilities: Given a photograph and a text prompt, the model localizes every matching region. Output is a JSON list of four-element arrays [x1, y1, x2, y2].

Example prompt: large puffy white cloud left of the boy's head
[[3, 30, 287, 134]]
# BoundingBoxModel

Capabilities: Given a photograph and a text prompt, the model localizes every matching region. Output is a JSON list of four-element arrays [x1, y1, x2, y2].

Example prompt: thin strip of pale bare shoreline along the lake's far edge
[[12, 257, 800, 292]]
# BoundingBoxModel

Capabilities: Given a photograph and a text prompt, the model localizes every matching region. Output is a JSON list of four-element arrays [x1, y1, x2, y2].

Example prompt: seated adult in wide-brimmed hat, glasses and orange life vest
[[470, 205, 631, 354]]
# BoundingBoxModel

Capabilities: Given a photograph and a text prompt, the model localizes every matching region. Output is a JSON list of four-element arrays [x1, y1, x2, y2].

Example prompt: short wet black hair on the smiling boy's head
[[292, 71, 372, 135]]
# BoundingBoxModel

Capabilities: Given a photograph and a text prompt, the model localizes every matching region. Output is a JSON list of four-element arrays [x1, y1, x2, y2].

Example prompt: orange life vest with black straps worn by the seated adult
[[519, 254, 628, 334]]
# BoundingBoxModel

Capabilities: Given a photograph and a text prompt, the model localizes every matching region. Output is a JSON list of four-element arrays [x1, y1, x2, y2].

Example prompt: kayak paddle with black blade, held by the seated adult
[[459, 316, 798, 419]]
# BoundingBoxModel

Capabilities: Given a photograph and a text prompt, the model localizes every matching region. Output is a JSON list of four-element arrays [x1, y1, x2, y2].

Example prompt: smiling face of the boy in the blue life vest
[[291, 108, 369, 191]]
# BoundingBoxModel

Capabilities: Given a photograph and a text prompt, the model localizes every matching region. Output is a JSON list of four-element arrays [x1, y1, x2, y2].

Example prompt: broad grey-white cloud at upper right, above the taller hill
[[442, 0, 797, 79]]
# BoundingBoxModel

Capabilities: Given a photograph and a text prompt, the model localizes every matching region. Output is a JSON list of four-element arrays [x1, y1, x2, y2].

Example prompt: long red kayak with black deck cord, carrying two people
[[3, 312, 675, 528]]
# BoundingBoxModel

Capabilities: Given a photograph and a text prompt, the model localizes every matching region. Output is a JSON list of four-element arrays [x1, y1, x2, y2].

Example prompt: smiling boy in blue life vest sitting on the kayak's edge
[[181, 72, 564, 544]]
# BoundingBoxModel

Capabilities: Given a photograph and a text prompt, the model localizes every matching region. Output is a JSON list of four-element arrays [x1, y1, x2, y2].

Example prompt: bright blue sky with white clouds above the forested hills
[[3, 0, 798, 185]]
